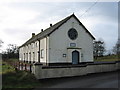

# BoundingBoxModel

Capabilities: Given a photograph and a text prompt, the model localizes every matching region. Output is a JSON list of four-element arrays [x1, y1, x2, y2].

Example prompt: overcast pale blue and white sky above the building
[[0, 1, 118, 53]]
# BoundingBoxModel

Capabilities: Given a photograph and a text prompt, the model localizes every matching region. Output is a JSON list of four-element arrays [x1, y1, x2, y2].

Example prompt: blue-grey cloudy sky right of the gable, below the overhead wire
[[76, 3, 118, 50]]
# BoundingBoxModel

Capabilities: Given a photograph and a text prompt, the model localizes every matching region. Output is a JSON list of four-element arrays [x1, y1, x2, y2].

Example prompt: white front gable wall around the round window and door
[[49, 17, 93, 63]]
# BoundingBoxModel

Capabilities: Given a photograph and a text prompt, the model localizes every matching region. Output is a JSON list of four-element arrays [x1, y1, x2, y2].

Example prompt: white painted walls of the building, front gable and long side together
[[19, 17, 93, 63]]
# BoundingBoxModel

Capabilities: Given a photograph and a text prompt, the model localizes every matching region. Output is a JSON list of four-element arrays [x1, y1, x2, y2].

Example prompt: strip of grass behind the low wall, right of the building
[[94, 55, 118, 61]]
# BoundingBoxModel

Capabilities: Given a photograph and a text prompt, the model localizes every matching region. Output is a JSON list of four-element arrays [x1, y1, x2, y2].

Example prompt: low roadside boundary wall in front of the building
[[32, 62, 120, 79]]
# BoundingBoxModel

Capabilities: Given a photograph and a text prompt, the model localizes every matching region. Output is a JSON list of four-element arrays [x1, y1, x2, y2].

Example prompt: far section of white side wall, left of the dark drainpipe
[[19, 41, 39, 62]]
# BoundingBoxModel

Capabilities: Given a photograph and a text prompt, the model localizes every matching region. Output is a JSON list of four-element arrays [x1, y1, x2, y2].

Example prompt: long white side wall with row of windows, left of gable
[[19, 34, 49, 63]]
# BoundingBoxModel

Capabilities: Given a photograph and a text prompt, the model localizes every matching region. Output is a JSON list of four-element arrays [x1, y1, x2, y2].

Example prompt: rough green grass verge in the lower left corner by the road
[[2, 59, 42, 88]]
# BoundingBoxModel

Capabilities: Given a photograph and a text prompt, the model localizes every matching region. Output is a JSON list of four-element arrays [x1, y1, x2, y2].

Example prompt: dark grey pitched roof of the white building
[[19, 14, 95, 48]]
